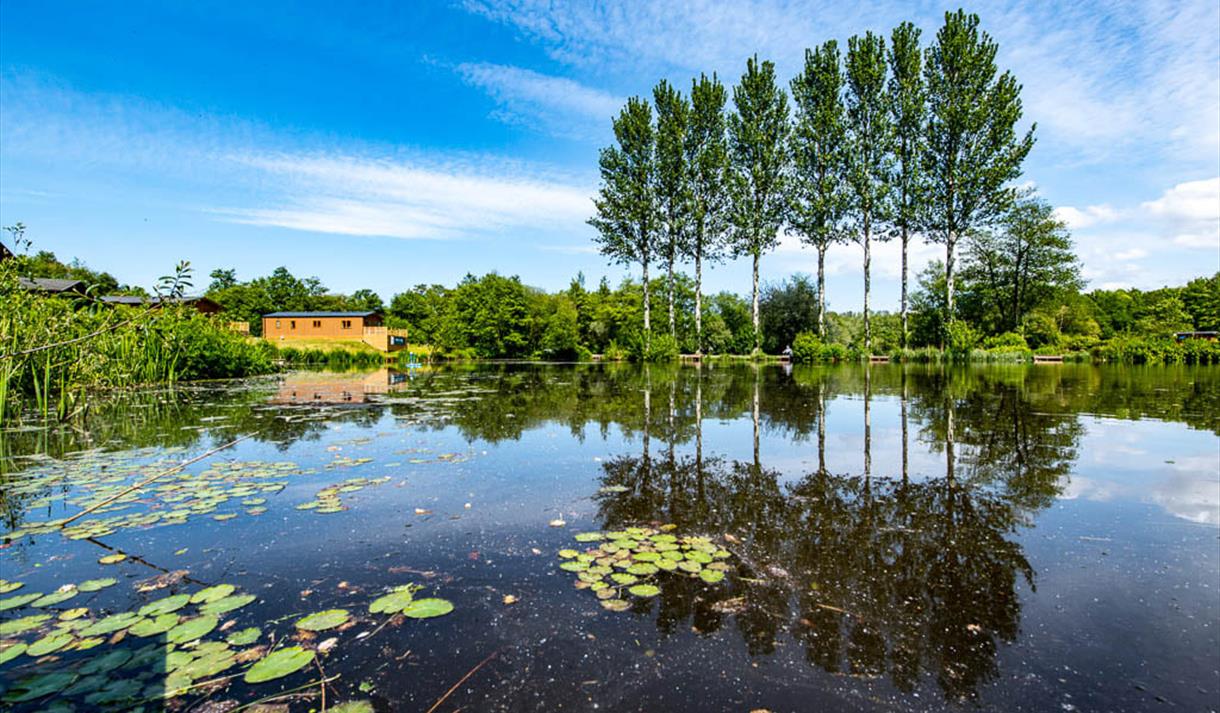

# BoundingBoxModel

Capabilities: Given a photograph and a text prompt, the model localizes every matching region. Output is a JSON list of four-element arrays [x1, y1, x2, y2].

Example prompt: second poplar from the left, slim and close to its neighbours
[[653, 79, 691, 336]]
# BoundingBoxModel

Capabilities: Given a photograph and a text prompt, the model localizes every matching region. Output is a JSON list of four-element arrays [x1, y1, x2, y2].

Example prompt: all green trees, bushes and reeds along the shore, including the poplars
[[0, 10, 1220, 421]]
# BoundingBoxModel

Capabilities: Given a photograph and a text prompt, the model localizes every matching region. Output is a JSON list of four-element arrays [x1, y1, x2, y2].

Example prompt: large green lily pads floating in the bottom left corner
[[0, 579, 454, 712]]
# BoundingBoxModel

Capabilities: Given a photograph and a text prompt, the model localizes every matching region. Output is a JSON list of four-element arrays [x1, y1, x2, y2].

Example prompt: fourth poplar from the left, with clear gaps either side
[[728, 55, 788, 352]]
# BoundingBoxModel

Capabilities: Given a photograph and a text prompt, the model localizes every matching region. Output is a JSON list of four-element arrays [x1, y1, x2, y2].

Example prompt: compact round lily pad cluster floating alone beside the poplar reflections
[[559, 525, 732, 612]]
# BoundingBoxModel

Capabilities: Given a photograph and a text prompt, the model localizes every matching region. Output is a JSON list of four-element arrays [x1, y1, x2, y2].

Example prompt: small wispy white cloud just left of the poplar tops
[[456, 62, 622, 137]]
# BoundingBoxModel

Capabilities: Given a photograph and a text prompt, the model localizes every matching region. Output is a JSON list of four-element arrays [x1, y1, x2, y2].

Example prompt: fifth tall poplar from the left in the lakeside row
[[788, 40, 848, 338]]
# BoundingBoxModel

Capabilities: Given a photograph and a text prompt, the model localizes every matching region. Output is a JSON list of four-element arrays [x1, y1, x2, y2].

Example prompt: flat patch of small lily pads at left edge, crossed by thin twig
[[4, 454, 307, 540]]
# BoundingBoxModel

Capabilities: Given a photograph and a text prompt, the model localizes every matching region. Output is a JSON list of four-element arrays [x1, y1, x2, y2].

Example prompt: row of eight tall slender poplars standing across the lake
[[589, 10, 1033, 349]]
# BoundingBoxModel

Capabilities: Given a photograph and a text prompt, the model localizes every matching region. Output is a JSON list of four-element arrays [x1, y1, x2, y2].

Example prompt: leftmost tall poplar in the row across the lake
[[589, 96, 658, 352]]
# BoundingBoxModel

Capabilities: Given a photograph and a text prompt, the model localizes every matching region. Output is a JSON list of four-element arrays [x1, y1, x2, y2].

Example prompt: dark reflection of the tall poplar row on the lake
[[597, 368, 1081, 698]]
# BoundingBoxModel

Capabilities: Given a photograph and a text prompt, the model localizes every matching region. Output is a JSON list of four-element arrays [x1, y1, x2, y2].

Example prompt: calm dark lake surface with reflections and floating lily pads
[[0, 365, 1220, 712]]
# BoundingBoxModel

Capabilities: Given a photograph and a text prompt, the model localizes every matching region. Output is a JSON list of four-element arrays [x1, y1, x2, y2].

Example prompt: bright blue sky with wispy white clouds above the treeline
[[0, 0, 1220, 309]]
